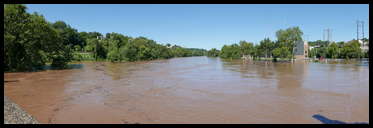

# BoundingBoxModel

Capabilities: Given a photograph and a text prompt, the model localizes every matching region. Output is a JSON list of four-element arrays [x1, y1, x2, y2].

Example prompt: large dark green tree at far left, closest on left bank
[[4, 4, 71, 71]]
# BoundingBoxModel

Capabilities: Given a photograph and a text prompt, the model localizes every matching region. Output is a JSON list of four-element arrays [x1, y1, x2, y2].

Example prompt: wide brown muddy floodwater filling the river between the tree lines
[[4, 57, 369, 123]]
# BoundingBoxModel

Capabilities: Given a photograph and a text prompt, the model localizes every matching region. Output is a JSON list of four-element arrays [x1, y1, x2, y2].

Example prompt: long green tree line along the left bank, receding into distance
[[4, 4, 207, 71]]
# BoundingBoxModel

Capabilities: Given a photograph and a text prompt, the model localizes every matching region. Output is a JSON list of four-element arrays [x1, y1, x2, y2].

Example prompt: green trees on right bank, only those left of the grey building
[[207, 27, 303, 60]]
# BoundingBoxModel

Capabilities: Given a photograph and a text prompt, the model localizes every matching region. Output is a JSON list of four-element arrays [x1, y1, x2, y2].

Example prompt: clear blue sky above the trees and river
[[26, 4, 369, 50]]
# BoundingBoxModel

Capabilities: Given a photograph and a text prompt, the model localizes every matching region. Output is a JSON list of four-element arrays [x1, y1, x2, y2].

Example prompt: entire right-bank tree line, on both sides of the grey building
[[207, 27, 369, 61]]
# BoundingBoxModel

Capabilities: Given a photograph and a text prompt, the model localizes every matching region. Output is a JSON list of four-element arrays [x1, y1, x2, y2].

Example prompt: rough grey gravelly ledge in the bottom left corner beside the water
[[4, 96, 38, 124]]
